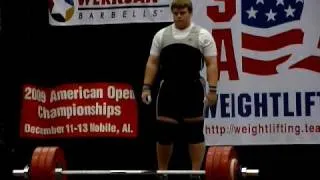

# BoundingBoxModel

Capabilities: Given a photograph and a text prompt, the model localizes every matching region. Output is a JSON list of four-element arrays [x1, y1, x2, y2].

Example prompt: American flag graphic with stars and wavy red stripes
[[241, 0, 320, 75]]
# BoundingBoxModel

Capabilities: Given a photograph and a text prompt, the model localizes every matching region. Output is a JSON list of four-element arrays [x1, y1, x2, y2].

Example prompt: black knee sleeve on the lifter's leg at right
[[184, 120, 204, 144]]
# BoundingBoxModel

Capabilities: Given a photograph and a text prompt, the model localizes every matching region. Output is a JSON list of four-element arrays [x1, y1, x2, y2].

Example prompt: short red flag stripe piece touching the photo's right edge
[[290, 56, 320, 73]]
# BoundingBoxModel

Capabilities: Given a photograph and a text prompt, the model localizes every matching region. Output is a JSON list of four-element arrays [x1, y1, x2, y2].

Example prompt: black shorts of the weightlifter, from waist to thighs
[[156, 79, 205, 121]]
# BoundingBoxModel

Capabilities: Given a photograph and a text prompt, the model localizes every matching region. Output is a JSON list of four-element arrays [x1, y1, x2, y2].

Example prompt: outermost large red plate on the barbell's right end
[[218, 146, 237, 180]]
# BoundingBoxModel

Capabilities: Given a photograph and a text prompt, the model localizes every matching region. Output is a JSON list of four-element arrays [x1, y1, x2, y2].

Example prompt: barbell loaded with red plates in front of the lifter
[[12, 146, 259, 180]]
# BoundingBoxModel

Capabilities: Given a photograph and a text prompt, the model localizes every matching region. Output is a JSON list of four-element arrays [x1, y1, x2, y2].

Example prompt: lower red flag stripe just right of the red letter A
[[242, 55, 291, 75]]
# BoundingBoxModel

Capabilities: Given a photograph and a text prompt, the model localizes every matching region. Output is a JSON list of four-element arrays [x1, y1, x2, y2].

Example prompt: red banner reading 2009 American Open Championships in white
[[20, 83, 138, 138]]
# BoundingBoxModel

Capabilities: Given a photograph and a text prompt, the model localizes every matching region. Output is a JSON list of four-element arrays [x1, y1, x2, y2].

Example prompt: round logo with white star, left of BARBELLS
[[48, 0, 74, 22]]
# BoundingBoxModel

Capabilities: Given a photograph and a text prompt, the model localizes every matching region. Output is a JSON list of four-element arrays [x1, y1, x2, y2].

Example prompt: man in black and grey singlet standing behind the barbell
[[141, 0, 218, 179]]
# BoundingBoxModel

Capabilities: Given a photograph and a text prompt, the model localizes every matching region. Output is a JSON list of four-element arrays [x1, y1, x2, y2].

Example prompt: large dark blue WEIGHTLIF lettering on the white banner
[[204, 92, 320, 118]]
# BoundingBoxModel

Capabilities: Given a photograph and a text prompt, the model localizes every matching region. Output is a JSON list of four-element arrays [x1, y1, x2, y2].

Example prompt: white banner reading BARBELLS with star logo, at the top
[[48, 0, 172, 26]]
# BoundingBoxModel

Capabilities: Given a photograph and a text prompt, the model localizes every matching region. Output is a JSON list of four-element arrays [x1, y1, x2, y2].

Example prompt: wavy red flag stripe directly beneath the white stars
[[242, 29, 304, 51]]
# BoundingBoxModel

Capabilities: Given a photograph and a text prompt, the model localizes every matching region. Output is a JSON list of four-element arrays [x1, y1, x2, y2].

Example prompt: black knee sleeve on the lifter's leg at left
[[156, 120, 178, 145]]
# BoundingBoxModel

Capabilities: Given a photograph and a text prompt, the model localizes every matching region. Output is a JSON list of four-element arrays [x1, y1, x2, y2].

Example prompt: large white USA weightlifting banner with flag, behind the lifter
[[193, 0, 320, 145]]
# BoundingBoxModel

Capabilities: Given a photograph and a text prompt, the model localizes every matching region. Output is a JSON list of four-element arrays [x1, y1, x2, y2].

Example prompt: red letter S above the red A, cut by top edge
[[207, 0, 236, 22]]
